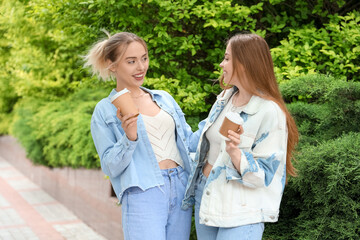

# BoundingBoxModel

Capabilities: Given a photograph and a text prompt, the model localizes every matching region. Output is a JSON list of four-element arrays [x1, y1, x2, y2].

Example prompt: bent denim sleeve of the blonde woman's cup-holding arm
[[91, 106, 138, 177]]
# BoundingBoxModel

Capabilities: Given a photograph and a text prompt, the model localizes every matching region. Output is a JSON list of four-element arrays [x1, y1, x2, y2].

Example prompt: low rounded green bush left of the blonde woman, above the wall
[[11, 88, 110, 168]]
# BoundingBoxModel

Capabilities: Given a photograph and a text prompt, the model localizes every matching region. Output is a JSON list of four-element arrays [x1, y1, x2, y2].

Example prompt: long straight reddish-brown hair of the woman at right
[[220, 34, 299, 176]]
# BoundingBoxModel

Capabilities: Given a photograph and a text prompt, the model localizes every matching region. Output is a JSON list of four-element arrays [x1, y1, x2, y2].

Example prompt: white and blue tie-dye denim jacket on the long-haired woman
[[182, 88, 287, 227]]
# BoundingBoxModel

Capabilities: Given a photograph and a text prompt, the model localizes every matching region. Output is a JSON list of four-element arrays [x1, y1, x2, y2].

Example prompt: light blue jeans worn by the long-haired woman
[[195, 171, 264, 240]]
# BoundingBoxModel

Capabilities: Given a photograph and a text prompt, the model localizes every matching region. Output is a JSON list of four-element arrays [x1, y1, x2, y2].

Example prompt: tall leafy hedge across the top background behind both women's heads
[[0, 0, 358, 109]]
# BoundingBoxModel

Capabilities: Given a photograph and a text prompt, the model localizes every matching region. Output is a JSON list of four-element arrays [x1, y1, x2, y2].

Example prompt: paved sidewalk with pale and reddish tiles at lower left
[[0, 157, 105, 240]]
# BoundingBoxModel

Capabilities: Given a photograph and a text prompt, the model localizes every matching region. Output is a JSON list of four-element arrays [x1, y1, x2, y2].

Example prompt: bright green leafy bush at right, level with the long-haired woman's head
[[271, 11, 360, 81]]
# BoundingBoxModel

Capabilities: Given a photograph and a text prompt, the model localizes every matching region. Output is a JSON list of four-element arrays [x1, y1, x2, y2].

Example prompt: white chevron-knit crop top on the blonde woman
[[142, 109, 184, 167]]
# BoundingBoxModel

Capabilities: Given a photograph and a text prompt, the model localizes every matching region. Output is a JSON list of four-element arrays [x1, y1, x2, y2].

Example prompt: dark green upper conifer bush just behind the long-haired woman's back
[[280, 75, 360, 146]]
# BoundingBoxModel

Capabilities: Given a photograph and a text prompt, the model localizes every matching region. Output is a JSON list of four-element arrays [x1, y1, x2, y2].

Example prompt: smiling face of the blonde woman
[[111, 42, 149, 89]]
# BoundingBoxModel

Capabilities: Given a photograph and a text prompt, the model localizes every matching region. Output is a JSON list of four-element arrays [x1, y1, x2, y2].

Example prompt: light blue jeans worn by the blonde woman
[[121, 166, 192, 240]]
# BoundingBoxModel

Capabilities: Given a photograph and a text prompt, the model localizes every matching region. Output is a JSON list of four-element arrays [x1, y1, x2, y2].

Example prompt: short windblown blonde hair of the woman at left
[[84, 30, 147, 81]]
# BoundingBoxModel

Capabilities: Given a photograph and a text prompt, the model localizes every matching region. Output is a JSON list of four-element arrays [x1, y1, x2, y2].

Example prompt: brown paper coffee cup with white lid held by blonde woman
[[111, 88, 139, 117]]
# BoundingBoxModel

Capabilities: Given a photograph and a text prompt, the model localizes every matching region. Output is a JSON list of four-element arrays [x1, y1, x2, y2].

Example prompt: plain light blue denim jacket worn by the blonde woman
[[91, 88, 201, 202]]
